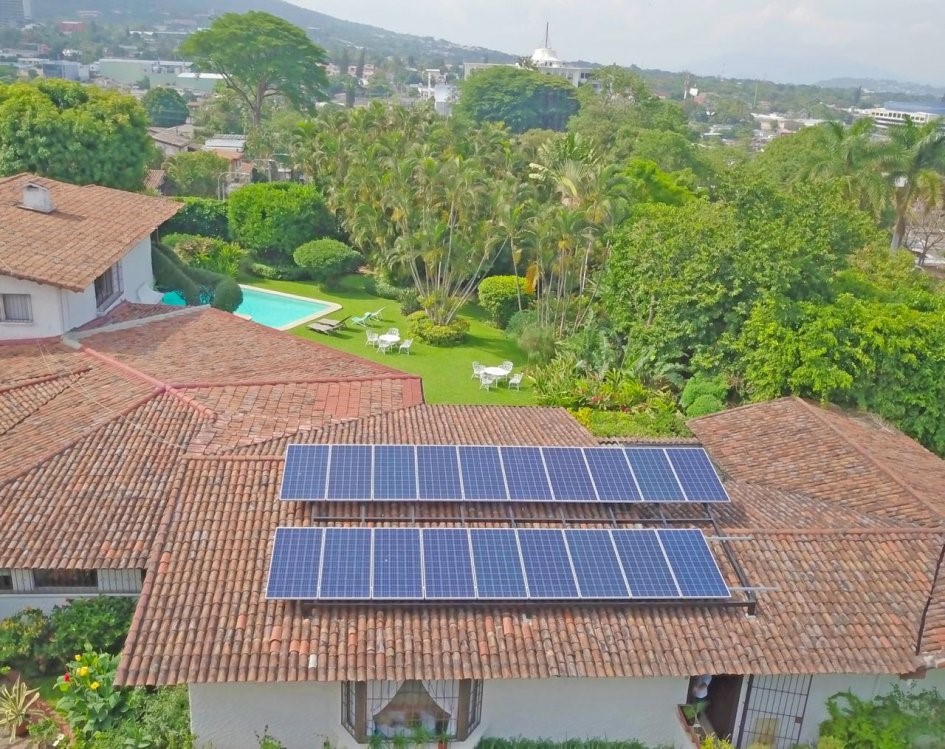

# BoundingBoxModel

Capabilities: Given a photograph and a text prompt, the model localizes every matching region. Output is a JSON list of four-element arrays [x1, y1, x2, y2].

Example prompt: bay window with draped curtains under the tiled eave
[[341, 680, 482, 743]]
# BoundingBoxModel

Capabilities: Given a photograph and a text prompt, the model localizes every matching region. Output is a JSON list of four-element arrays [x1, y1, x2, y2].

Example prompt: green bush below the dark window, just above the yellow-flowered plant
[[39, 596, 135, 669]]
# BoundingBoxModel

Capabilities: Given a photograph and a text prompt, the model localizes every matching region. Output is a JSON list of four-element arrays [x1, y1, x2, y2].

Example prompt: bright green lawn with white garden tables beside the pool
[[240, 275, 535, 406]]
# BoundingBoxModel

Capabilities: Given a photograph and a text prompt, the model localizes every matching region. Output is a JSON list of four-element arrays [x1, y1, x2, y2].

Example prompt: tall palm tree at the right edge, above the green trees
[[878, 119, 945, 252]]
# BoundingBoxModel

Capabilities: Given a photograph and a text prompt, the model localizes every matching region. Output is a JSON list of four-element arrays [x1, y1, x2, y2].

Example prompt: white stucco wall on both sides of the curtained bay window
[[190, 679, 688, 749]]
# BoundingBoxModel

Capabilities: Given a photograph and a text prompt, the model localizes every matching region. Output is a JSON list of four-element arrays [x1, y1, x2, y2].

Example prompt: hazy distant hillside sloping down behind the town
[[32, 0, 518, 65]]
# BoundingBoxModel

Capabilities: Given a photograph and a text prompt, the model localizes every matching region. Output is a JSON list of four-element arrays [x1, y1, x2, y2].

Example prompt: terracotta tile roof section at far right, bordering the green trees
[[689, 398, 945, 524]]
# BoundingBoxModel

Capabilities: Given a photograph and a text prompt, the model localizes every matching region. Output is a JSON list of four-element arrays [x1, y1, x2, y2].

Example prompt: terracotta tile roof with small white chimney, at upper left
[[0, 174, 181, 291]]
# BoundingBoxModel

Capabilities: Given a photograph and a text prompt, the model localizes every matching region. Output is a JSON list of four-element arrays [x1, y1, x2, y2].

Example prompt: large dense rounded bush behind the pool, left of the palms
[[229, 182, 335, 265]]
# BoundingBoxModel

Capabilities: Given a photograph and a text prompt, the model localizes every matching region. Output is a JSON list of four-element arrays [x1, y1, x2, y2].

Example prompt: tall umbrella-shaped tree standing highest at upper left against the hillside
[[180, 10, 328, 128]]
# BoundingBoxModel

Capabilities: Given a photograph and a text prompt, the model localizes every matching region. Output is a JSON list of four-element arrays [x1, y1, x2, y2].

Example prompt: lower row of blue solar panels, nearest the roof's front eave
[[266, 527, 730, 601]]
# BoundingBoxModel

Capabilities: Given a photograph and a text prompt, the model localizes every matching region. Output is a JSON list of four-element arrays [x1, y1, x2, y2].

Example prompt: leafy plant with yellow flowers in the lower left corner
[[56, 649, 128, 737]]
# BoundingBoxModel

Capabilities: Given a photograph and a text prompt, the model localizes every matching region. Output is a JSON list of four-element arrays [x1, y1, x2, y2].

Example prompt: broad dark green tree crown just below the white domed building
[[454, 66, 578, 133]]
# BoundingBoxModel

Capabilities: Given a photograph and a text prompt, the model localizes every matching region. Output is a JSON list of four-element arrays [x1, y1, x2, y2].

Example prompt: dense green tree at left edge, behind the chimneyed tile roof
[[0, 78, 153, 190]]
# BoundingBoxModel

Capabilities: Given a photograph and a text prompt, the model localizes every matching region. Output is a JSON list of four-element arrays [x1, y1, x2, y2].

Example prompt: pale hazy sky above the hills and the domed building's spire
[[292, 0, 945, 86]]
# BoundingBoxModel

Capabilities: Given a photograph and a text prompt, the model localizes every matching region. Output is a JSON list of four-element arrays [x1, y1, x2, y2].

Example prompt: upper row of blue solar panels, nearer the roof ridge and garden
[[281, 445, 728, 502]]
